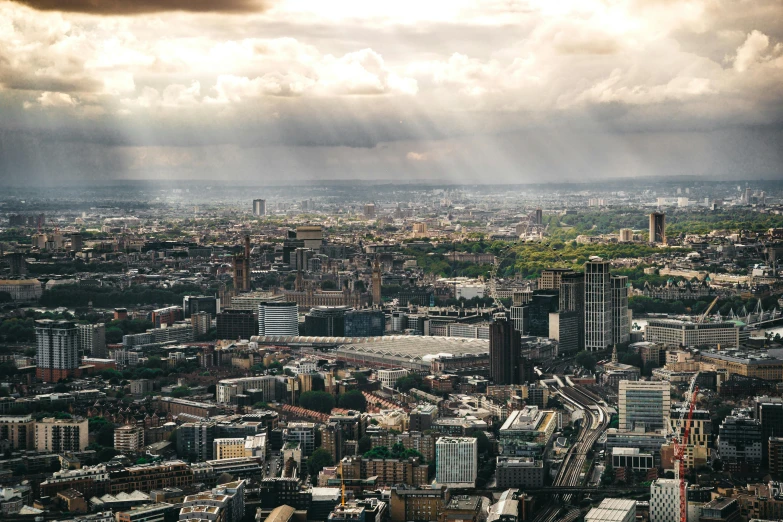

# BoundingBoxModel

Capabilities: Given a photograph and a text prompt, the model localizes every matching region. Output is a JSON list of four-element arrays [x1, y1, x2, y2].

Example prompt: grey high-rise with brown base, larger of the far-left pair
[[35, 319, 79, 382]]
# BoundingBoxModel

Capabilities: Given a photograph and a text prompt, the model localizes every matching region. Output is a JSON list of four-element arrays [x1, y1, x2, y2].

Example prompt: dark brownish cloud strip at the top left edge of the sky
[[11, 0, 268, 16]]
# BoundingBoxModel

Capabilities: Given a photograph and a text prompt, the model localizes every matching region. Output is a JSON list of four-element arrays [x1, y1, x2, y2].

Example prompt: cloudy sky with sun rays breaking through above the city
[[0, 0, 783, 186]]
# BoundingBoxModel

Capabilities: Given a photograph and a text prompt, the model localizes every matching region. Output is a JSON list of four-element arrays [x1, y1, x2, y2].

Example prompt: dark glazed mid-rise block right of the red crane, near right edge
[[718, 415, 768, 471]]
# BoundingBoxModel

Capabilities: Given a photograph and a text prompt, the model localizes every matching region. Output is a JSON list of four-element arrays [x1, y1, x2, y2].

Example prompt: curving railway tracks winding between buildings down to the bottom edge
[[533, 378, 610, 522]]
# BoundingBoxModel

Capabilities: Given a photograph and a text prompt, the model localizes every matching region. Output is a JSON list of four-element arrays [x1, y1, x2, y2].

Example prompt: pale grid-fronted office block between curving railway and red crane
[[617, 381, 671, 431]]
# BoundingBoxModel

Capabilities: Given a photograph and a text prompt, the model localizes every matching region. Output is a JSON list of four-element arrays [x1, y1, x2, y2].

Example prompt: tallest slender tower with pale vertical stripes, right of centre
[[584, 257, 613, 351]]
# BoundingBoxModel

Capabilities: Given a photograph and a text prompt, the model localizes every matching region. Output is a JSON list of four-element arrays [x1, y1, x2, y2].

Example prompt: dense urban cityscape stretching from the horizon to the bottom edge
[[0, 180, 783, 522]]
